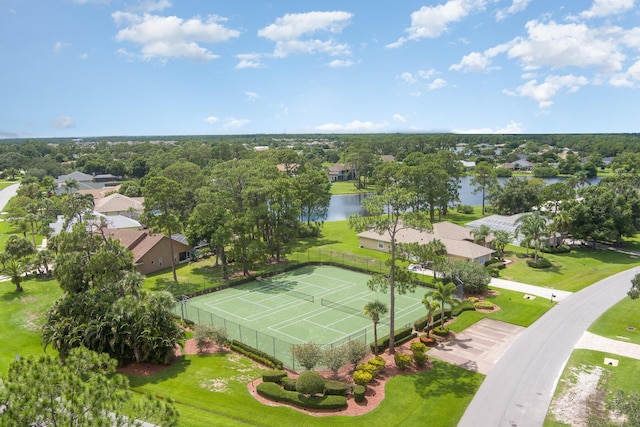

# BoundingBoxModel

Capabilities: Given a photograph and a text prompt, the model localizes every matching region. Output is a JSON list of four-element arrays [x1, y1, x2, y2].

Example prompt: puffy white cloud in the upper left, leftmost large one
[[111, 11, 240, 62]]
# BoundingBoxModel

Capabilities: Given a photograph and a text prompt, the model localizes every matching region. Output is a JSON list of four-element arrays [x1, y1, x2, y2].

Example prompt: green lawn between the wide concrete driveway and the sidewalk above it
[[449, 289, 556, 332]]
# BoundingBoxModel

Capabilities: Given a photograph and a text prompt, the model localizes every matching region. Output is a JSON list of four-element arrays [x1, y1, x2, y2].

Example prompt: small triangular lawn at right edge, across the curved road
[[589, 298, 640, 344]]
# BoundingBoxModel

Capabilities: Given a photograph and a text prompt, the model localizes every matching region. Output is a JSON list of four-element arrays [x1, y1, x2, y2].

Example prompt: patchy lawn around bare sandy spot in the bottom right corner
[[544, 350, 640, 427]]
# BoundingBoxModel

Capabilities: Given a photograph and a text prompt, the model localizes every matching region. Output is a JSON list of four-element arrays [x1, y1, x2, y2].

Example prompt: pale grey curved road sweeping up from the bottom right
[[458, 268, 636, 427]]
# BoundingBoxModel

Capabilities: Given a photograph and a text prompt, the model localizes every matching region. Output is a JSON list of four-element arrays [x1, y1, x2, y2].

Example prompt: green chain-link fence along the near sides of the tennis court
[[174, 299, 373, 371]]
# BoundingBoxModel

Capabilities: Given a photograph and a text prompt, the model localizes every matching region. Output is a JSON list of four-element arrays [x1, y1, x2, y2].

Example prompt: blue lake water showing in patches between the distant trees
[[326, 176, 600, 221]]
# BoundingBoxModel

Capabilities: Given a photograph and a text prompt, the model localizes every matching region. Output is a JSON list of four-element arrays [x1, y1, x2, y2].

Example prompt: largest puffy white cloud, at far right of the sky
[[508, 20, 625, 73]]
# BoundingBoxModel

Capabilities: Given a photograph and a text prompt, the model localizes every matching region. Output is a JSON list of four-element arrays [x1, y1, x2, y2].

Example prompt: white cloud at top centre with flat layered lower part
[[258, 11, 353, 58]]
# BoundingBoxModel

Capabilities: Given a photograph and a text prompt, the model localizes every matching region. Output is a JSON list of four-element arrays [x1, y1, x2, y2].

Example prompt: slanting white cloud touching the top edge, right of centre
[[387, 0, 486, 48]]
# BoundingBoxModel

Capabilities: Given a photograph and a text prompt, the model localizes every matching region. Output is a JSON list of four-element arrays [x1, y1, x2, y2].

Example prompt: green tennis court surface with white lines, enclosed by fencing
[[182, 266, 426, 370]]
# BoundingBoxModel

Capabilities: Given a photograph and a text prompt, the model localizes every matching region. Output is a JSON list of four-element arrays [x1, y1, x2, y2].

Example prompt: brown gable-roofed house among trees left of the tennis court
[[104, 229, 191, 274]]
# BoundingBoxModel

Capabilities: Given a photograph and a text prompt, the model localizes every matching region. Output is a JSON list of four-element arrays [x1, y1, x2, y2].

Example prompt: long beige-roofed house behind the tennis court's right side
[[358, 221, 495, 265]]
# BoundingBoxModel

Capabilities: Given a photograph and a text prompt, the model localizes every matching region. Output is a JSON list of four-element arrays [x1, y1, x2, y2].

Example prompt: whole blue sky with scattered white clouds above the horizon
[[0, 0, 640, 138]]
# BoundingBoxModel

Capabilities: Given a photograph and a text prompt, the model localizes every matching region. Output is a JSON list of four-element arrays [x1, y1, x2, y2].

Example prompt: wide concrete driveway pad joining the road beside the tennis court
[[428, 318, 525, 375]]
